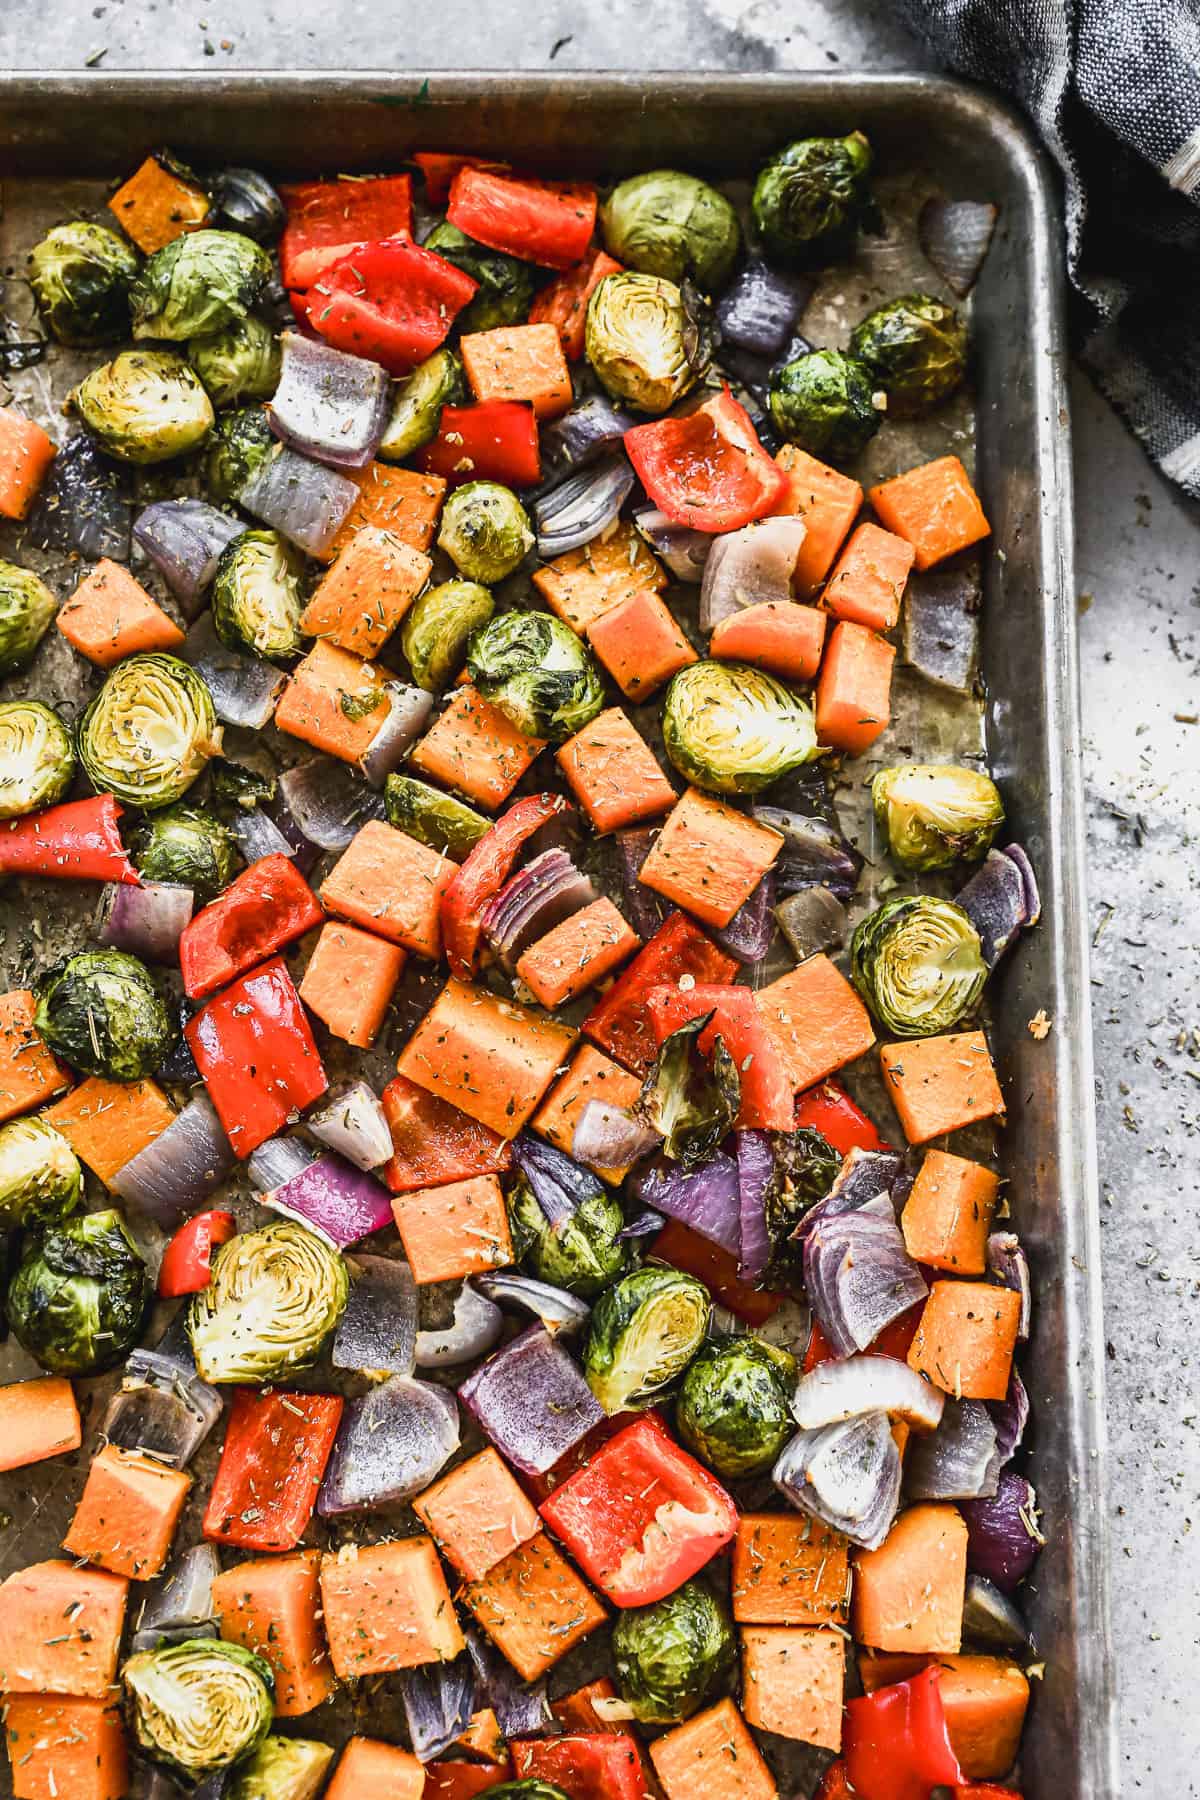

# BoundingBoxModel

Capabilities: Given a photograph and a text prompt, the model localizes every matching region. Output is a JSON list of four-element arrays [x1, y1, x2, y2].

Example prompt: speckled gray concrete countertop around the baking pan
[[0, 0, 1200, 1796]]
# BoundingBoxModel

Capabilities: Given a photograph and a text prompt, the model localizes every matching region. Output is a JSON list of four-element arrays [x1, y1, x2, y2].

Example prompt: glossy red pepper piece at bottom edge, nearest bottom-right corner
[[844, 1667, 963, 1800]]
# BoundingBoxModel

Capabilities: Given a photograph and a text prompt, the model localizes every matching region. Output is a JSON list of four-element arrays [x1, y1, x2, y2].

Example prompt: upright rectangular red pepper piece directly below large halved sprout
[[203, 1388, 344, 1550]]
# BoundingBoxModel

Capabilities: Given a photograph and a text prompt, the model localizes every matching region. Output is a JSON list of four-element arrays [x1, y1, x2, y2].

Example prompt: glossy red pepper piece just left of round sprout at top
[[446, 169, 596, 268]]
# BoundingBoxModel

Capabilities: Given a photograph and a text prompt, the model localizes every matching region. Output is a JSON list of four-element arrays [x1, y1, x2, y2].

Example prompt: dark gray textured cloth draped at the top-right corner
[[896, 0, 1200, 499]]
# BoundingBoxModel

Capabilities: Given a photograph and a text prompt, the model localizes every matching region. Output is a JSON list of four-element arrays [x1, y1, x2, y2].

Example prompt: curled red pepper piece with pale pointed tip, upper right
[[624, 387, 788, 531]]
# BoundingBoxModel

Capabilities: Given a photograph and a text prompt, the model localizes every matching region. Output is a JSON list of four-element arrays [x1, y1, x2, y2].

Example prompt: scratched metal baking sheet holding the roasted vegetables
[[0, 72, 1117, 1800]]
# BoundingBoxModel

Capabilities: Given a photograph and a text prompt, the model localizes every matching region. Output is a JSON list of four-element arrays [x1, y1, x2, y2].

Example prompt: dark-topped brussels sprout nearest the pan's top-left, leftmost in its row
[[29, 220, 142, 347]]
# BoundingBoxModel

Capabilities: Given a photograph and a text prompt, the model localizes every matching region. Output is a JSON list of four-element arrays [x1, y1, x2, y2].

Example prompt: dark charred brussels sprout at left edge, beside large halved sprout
[[7, 1211, 151, 1375]]
